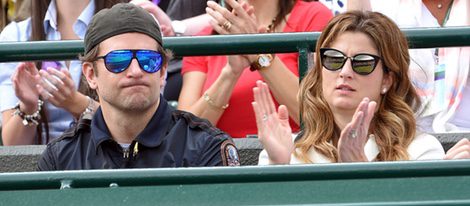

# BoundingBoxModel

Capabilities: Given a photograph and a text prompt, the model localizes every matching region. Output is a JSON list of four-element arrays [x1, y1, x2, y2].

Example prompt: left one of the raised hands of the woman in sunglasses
[[252, 81, 294, 164]]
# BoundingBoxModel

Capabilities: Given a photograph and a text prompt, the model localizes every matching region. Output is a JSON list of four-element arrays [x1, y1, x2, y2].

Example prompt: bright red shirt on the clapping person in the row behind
[[181, 0, 332, 138]]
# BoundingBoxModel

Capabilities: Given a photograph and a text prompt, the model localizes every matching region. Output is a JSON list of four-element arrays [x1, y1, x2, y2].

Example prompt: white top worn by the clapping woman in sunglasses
[[258, 133, 445, 165]]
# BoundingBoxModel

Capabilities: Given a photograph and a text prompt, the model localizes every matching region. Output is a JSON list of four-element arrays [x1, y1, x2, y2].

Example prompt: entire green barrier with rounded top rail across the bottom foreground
[[0, 160, 470, 206]]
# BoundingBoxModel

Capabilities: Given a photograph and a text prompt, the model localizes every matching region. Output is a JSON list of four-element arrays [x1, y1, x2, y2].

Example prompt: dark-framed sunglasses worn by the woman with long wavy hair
[[320, 48, 387, 75]]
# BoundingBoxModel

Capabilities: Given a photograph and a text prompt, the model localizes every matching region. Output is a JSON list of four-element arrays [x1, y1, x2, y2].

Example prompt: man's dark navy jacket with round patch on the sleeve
[[38, 98, 239, 170]]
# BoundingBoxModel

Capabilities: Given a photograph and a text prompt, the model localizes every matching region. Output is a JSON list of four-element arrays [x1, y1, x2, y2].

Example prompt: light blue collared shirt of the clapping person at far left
[[0, 0, 95, 142]]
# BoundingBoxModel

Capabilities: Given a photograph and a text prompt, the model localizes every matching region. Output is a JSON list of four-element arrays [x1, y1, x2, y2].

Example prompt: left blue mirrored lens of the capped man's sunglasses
[[105, 50, 132, 73]]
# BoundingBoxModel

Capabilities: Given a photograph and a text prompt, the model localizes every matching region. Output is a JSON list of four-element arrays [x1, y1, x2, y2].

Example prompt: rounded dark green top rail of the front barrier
[[0, 160, 470, 190]]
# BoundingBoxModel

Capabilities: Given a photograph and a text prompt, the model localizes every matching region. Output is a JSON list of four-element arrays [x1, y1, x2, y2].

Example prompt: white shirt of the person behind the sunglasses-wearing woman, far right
[[370, 0, 470, 133]]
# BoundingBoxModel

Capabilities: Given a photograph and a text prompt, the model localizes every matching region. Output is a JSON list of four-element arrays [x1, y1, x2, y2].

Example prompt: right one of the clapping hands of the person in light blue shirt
[[37, 67, 78, 110]]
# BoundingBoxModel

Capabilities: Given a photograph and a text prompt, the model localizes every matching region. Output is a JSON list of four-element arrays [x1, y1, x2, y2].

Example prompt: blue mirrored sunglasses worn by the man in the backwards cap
[[95, 49, 162, 73]]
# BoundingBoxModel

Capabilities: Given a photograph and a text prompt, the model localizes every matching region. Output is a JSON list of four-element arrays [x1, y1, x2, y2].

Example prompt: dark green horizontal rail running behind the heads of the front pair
[[0, 27, 470, 62]]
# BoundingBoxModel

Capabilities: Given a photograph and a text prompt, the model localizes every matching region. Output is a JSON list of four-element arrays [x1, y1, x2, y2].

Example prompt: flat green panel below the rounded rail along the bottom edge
[[0, 177, 470, 206]]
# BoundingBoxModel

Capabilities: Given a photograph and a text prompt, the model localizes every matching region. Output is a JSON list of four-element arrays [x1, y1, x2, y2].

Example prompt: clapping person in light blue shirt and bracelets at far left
[[0, 0, 124, 145]]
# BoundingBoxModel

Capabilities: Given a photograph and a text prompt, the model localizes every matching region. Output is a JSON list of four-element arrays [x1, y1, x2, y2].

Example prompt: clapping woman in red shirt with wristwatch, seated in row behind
[[178, 0, 332, 138]]
